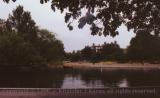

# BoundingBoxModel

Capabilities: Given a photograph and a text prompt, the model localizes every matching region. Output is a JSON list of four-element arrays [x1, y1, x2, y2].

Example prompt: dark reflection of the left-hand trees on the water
[[0, 69, 64, 88]]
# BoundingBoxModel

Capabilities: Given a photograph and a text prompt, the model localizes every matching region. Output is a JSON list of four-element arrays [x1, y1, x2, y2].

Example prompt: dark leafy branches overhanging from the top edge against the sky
[[3, 0, 160, 37]]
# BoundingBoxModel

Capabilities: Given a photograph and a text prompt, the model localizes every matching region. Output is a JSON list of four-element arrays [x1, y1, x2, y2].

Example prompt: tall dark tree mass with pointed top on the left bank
[[0, 6, 64, 69]]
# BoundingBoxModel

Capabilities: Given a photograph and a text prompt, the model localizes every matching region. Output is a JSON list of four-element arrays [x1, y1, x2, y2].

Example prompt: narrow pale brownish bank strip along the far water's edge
[[64, 62, 160, 69]]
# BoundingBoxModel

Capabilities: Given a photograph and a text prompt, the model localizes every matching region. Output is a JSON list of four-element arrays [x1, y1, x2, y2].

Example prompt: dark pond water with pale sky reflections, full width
[[0, 69, 160, 88]]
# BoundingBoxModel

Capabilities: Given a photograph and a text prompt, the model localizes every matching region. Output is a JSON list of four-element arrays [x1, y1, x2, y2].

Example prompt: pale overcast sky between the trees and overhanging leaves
[[0, 0, 135, 52]]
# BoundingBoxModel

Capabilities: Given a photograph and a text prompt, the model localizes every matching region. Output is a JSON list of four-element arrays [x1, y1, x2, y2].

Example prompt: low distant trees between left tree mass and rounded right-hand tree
[[66, 42, 126, 63]]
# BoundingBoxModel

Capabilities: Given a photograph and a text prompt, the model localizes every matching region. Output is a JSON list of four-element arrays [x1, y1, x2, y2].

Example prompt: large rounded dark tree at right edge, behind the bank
[[127, 31, 160, 63]]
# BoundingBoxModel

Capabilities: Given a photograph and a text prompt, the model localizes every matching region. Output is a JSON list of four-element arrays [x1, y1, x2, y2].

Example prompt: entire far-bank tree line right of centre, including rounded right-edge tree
[[66, 30, 160, 63]]
